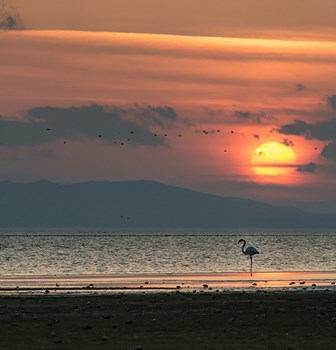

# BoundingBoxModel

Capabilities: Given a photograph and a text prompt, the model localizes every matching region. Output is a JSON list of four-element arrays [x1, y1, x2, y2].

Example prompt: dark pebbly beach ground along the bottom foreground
[[0, 291, 336, 350]]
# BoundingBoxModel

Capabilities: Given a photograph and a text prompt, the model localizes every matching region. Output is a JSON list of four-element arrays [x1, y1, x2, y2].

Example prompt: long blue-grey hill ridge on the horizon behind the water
[[0, 181, 336, 228]]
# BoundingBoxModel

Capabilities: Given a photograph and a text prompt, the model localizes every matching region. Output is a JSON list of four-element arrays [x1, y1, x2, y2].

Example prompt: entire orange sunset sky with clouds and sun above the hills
[[0, 0, 336, 202]]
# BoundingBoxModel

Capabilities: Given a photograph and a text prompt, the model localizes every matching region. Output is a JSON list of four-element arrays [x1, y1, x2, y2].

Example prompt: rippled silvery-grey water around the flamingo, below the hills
[[0, 230, 336, 276]]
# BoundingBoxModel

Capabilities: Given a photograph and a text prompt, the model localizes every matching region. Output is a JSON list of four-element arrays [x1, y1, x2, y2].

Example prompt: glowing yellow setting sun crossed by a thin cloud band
[[252, 142, 296, 178]]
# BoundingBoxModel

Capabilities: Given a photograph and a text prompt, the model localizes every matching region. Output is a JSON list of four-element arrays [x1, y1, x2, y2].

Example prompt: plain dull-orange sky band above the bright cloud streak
[[6, 0, 336, 39]]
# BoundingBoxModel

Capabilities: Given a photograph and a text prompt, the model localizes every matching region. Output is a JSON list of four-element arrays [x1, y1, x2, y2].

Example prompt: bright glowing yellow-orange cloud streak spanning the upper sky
[[5, 30, 336, 66]]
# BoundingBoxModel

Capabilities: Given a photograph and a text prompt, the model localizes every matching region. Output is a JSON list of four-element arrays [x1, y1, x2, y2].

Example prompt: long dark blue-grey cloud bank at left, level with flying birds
[[0, 104, 177, 148]]
